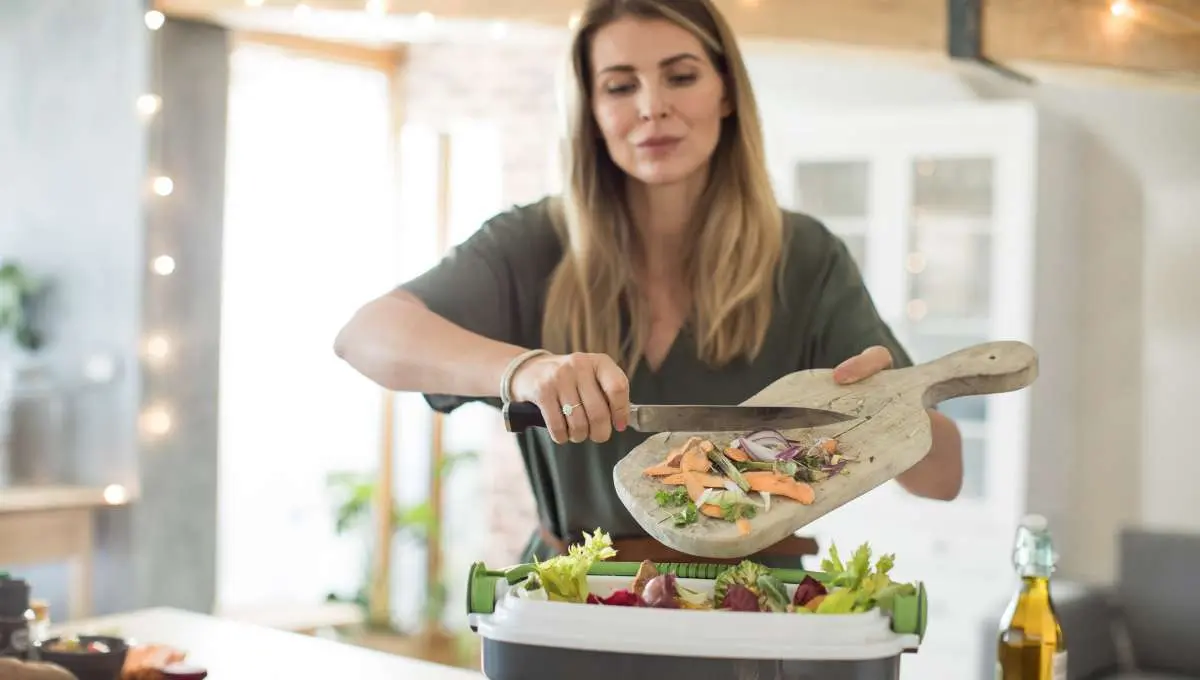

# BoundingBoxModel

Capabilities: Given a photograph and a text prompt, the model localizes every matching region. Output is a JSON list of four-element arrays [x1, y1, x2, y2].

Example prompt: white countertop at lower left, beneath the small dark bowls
[[53, 608, 484, 680]]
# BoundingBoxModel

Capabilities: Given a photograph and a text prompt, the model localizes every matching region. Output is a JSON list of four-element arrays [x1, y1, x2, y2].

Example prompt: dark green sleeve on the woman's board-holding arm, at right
[[812, 234, 912, 368]]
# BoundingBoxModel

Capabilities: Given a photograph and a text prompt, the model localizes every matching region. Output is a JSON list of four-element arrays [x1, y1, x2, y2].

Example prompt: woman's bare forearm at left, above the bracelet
[[334, 291, 524, 397]]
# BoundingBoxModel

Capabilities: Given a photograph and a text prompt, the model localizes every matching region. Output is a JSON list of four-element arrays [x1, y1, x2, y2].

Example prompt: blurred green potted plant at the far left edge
[[0, 261, 42, 487]]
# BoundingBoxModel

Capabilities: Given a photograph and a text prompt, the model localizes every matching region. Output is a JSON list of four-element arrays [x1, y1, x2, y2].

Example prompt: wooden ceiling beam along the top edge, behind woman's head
[[155, 0, 1200, 74]]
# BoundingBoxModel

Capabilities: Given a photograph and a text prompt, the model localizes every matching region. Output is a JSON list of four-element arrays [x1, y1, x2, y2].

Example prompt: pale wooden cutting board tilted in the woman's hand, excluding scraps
[[613, 342, 1038, 559]]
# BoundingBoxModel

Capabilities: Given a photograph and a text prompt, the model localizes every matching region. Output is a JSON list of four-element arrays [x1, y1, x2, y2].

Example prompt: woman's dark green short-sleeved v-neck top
[[400, 197, 912, 566]]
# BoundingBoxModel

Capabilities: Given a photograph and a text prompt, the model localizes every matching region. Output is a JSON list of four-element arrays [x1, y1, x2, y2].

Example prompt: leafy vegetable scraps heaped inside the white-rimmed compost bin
[[517, 529, 917, 614]]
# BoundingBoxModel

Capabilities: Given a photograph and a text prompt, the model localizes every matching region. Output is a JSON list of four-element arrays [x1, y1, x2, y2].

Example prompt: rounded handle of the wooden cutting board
[[899, 341, 1038, 408]]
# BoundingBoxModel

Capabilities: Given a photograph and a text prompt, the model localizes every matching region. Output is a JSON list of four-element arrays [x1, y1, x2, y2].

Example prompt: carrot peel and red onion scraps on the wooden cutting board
[[642, 429, 851, 535]]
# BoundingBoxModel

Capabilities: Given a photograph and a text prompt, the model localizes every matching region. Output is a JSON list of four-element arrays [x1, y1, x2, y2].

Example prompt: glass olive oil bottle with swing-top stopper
[[996, 514, 1067, 680]]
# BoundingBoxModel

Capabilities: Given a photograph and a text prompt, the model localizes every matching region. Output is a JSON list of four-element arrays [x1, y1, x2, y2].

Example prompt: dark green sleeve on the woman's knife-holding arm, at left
[[397, 201, 557, 413]]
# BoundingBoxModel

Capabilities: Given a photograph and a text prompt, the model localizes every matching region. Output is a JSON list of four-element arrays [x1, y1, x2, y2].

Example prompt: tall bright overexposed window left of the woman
[[217, 44, 401, 609]]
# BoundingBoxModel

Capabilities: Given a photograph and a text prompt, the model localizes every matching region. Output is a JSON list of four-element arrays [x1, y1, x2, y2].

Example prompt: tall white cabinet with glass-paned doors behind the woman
[[764, 102, 1078, 678]]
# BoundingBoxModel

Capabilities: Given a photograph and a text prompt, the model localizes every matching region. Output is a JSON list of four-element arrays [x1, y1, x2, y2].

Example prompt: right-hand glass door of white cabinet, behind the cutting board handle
[[898, 157, 995, 498]]
